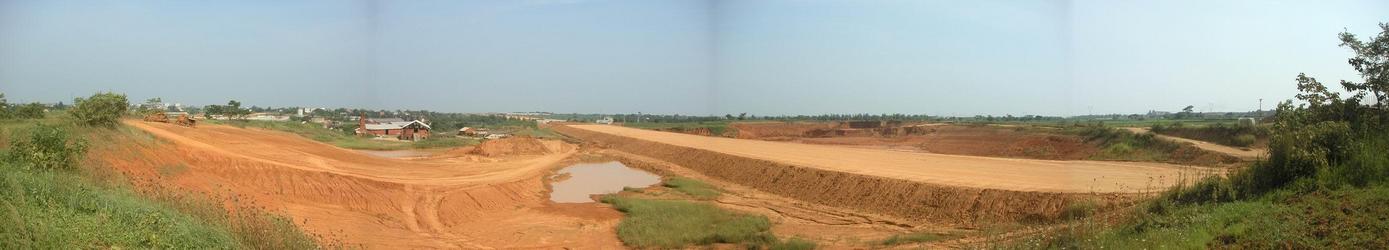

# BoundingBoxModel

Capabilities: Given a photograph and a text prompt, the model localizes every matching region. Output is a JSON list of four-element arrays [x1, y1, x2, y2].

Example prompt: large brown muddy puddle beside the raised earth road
[[550, 161, 661, 203]]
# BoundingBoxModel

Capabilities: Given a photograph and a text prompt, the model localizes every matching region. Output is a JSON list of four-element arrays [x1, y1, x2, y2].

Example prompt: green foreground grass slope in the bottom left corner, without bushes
[[0, 164, 244, 249]]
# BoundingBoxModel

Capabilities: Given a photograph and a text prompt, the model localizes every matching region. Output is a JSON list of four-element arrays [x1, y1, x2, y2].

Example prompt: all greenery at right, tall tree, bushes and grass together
[[1014, 24, 1389, 249]]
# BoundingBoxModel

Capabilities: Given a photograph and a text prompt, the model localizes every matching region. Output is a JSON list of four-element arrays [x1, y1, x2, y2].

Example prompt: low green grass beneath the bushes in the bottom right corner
[[1013, 186, 1389, 249]]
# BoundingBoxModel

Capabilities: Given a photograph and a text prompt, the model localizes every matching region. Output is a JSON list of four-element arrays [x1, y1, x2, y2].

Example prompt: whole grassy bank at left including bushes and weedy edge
[[0, 119, 318, 249]]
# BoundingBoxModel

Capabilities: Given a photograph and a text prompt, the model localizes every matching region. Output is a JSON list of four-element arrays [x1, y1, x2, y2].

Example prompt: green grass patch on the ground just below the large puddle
[[601, 194, 778, 249]]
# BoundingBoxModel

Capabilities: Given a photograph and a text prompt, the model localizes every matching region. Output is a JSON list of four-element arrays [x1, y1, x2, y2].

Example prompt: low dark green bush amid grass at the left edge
[[6, 124, 86, 169]]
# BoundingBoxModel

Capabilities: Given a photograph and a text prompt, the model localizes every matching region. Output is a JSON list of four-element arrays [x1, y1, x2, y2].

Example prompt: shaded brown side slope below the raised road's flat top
[[556, 126, 1132, 225]]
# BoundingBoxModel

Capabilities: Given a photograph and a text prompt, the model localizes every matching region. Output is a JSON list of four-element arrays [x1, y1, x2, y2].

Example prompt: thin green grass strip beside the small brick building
[[208, 119, 478, 150]]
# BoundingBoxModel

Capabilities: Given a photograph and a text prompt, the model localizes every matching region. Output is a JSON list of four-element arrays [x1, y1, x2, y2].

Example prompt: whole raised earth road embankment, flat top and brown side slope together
[[556, 125, 1208, 226]]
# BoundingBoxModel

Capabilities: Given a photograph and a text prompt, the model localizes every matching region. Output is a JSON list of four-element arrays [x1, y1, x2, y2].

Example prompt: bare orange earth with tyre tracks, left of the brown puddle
[[118, 121, 621, 249]]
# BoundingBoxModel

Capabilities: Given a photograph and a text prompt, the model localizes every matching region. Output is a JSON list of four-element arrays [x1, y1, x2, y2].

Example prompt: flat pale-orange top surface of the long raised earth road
[[568, 125, 1217, 193]]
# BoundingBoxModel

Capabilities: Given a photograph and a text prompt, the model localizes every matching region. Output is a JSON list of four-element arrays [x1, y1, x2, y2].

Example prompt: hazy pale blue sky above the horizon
[[0, 0, 1389, 115]]
